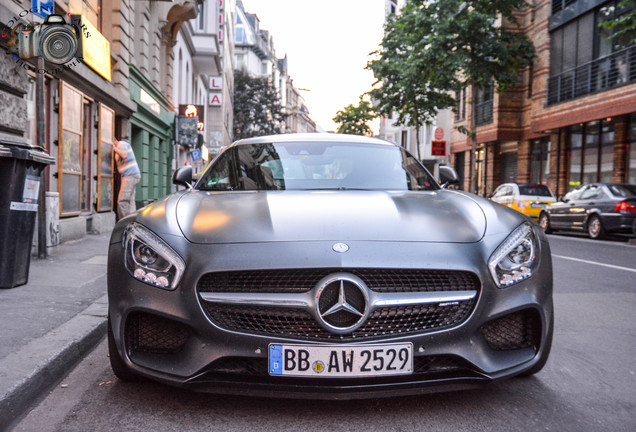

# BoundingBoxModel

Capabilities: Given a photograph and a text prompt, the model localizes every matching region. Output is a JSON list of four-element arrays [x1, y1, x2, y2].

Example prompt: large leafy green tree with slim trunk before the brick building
[[368, 0, 535, 192]]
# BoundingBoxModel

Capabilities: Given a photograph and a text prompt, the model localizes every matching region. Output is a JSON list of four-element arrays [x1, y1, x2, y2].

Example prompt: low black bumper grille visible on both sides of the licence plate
[[207, 356, 470, 379]]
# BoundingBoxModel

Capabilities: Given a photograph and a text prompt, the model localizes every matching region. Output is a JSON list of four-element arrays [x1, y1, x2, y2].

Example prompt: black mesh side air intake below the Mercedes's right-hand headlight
[[481, 309, 541, 351]]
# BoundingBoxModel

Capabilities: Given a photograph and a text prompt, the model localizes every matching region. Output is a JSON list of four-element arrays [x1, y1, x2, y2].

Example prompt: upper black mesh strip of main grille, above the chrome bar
[[197, 268, 479, 294]]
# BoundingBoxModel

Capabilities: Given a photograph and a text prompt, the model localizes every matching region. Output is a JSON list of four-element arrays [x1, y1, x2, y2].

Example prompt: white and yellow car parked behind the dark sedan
[[490, 183, 556, 219]]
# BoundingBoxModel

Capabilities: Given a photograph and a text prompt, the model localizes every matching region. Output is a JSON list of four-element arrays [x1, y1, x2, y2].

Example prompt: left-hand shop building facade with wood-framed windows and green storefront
[[0, 0, 199, 244]]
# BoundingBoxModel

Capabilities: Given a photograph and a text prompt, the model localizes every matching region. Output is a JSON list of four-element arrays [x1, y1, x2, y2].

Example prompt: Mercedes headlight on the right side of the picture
[[488, 223, 538, 288]]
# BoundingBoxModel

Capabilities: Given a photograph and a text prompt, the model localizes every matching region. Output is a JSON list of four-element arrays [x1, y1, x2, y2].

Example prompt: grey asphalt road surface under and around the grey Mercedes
[[15, 235, 636, 432]]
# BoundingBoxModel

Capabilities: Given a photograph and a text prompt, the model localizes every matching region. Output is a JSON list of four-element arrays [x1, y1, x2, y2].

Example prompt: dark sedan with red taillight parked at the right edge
[[539, 183, 636, 239]]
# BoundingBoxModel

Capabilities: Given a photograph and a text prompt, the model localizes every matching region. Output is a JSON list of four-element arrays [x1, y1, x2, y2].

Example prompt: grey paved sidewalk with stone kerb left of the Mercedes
[[0, 233, 110, 431]]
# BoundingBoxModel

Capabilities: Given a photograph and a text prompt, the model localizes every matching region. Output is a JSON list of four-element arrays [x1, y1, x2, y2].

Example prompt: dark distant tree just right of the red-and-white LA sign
[[233, 71, 284, 139]]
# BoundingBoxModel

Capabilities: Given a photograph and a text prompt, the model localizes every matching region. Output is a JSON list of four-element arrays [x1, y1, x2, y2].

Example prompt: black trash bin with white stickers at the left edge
[[0, 140, 55, 288]]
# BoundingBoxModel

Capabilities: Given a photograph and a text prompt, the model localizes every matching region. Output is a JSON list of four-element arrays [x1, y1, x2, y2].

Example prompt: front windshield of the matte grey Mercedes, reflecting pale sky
[[196, 142, 439, 190]]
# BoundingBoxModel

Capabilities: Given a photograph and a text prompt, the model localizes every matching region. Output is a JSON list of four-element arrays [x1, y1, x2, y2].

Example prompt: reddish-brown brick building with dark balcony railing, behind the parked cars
[[451, 0, 636, 196]]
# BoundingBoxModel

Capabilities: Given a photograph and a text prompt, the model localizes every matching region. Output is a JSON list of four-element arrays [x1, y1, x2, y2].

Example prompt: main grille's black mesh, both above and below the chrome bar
[[198, 269, 479, 341]]
